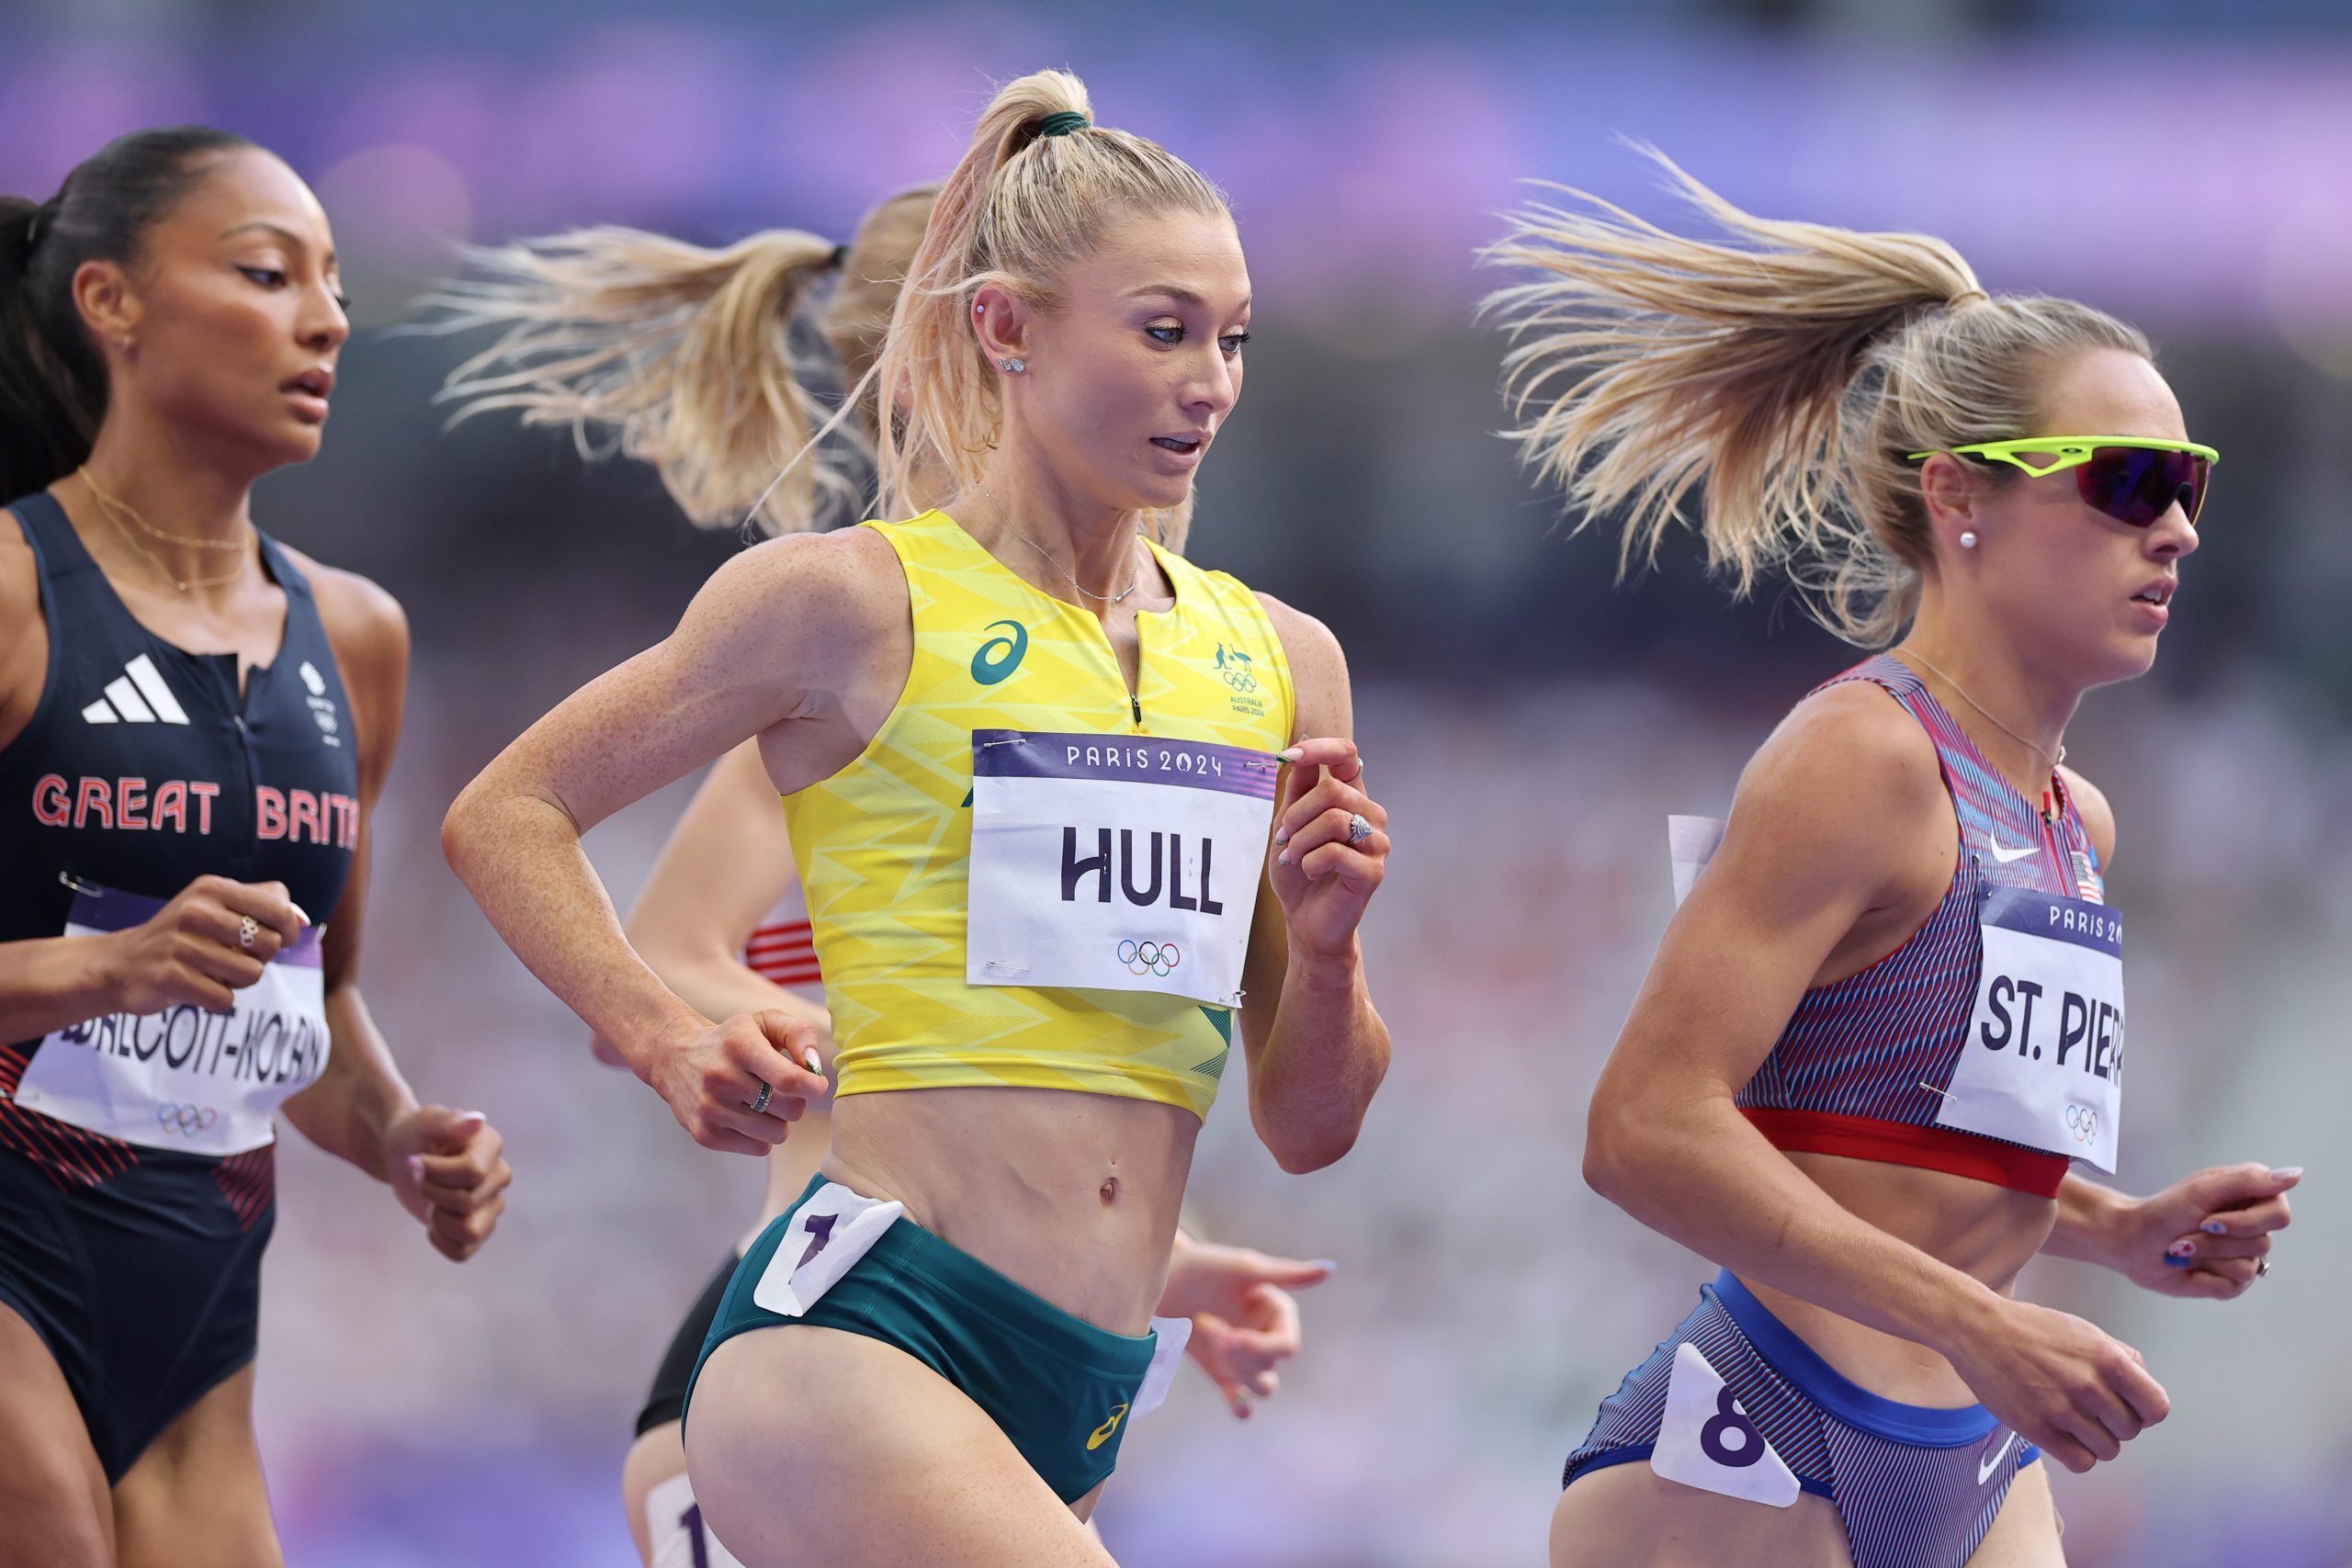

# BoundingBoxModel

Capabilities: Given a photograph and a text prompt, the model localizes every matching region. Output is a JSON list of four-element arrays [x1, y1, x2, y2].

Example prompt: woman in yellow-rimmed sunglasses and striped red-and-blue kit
[[1491, 160, 2301, 1568]]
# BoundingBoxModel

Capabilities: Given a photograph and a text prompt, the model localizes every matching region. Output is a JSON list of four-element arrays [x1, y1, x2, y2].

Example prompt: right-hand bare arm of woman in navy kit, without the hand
[[285, 559, 416, 1180]]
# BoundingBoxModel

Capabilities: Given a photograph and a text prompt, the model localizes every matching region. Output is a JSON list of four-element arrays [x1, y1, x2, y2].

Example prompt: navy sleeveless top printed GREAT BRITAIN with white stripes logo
[[0, 493, 360, 1180]]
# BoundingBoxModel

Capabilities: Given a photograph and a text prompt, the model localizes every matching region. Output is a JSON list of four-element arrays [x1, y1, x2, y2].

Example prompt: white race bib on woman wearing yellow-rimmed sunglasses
[[1936, 886, 2124, 1173]]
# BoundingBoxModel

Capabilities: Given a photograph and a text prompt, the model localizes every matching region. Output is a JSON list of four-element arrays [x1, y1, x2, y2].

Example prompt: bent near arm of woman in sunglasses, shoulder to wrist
[[1585, 684, 1992, 1345]]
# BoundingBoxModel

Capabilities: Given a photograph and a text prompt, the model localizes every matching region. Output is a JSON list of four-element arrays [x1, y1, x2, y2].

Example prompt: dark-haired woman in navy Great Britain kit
[[0, 127, 508, 1568]]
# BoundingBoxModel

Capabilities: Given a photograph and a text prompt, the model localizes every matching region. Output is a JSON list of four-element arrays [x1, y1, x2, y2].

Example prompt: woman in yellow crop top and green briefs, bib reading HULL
[[445, 73, 1387, 1568]]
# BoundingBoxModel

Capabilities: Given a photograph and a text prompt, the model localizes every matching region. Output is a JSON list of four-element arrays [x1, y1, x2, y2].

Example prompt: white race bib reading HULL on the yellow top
[[965, 728, 1280, 1006]]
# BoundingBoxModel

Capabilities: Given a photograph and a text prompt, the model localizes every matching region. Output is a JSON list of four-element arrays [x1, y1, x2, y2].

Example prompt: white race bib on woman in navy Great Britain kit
[[17, 886, 327, 1155]]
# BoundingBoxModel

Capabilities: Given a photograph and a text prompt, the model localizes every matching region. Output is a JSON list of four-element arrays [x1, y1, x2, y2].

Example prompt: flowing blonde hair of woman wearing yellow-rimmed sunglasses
[[1482, 148, 2154, 647]]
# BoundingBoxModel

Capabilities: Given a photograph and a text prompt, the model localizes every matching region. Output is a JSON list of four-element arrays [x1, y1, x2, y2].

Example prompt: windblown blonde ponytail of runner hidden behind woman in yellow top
[[424, 228, 858, 534]]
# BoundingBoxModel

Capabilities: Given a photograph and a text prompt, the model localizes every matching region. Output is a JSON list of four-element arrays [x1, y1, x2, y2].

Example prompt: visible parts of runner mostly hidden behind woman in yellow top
[[433, 184, 1331, 1568]]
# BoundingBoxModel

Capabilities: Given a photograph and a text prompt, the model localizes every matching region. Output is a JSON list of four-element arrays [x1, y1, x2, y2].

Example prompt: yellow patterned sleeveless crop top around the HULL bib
[[783, 513, 1296, 1117]]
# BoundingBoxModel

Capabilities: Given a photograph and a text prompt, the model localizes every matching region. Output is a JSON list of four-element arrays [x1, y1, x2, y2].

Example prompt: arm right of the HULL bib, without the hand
[[1239, 594, 1390, 1173]]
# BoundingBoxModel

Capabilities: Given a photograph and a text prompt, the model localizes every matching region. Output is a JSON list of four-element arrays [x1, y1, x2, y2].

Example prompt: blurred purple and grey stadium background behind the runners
[[0, 0, 2352, 1568]]
